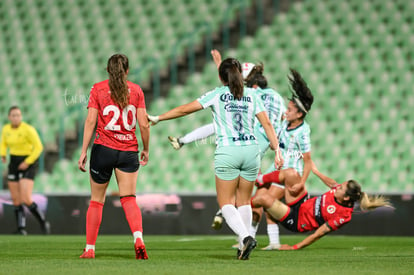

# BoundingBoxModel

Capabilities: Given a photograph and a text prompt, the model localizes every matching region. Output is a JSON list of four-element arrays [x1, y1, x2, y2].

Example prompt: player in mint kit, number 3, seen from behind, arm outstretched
[[148, 58, 283, 260]]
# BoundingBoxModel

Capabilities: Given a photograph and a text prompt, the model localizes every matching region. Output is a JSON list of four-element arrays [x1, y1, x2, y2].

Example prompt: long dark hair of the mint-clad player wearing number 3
[[219, 58, 243, 100]]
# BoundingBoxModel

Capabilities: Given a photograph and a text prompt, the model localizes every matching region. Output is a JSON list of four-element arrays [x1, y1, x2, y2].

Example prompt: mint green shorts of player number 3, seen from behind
[[214, 145, 260, 181]]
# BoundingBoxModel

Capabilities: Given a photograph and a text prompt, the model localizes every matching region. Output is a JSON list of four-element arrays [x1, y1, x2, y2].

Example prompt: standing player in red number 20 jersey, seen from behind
[[78, 54, 150, 260]]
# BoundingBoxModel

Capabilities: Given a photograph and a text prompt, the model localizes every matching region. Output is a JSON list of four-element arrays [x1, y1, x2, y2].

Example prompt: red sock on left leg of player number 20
[[86, 201, 103, 245]]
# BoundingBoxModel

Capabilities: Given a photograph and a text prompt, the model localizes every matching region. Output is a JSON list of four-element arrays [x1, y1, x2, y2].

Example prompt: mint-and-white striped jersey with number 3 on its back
[[197, 86, 265, 147]]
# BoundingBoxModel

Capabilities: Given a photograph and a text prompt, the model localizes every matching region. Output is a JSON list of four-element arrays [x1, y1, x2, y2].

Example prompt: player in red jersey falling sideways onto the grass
[[252, 164, 392, 250]]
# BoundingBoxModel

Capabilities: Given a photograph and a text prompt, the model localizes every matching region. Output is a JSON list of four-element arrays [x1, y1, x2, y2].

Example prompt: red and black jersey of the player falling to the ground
[[297, 187, 354, 232]]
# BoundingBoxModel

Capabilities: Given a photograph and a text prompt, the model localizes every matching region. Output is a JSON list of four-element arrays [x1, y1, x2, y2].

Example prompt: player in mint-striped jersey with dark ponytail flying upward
[[252, 69, 313, 250]]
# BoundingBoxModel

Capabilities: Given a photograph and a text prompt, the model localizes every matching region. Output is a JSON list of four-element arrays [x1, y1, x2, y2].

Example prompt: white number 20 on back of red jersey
[[103, 105, 137, 131]]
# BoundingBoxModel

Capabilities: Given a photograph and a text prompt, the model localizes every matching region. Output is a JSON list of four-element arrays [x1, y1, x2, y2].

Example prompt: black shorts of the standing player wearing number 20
[[89, 144, 139, 183]]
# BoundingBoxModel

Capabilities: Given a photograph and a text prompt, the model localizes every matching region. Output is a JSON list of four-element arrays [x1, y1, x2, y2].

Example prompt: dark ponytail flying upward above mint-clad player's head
[[288, 69, 313, 118]]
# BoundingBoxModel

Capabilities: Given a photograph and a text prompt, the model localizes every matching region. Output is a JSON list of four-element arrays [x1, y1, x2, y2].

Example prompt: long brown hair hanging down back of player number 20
[[107, 54, 129, 109]]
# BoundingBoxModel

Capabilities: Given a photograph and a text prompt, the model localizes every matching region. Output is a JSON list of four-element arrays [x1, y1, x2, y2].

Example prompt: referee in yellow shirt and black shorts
[[0, 106, 50, 235]]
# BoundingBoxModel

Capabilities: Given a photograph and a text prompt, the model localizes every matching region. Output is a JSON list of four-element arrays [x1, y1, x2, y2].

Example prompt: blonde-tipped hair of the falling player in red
[[345, 180, 392, 210]]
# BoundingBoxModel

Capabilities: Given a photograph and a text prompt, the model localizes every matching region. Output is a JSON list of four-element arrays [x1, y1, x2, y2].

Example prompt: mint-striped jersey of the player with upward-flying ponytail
[[277, 120, 311, 175]]
